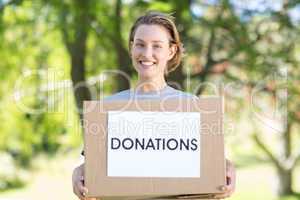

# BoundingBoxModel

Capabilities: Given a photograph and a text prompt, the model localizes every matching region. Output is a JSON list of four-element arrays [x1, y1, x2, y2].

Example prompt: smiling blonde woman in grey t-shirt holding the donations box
[[72, 12, 235, 199]]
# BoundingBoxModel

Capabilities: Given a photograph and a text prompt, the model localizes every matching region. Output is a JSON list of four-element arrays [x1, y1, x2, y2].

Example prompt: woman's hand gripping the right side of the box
[[214, 159, 235, 199]]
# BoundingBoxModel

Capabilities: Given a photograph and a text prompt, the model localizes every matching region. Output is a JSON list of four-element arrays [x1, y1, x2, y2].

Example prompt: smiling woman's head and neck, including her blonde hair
[[129, 13, 183, 90]]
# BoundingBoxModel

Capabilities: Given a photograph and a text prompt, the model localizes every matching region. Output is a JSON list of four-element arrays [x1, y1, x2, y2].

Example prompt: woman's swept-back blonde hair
[[129, 11, 184, 73]]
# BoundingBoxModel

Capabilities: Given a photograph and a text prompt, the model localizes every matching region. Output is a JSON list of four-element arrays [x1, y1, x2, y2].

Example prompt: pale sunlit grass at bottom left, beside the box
[[0, 152, 78, 200]]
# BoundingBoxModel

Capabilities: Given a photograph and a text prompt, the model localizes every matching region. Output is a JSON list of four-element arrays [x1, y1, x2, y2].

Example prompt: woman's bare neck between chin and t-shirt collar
[[135, 77, 167, 92]]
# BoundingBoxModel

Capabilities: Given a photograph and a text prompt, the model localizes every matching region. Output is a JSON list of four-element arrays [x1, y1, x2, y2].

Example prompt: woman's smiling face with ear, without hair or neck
[[131, 25, 175, 80]]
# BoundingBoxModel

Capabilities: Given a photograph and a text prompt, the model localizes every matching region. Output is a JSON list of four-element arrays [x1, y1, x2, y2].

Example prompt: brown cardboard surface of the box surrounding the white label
[[84, 98, 226, 199]]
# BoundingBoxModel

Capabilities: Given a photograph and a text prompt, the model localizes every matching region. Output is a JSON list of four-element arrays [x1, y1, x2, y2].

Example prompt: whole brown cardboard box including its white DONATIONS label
[[84, 98, 226, 199]]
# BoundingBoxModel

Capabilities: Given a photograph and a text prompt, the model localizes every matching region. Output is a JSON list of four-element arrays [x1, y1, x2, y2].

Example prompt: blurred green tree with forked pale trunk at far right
[[186, 0, 300, 195]]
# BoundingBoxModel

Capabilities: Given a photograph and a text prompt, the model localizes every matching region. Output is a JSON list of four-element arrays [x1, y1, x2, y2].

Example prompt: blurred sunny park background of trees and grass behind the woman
[[0, 0, 300, 200]]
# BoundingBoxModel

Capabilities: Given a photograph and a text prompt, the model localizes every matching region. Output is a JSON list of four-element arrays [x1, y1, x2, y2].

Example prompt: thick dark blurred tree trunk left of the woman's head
[[61, 0, 91, 122]]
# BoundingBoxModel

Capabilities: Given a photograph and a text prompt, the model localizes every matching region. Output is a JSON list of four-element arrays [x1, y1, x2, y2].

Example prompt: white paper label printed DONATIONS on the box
[[107, 111, 201, 177]]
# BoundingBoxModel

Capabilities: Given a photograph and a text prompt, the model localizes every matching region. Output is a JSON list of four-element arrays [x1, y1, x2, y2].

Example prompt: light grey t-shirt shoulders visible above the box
[[104, 85, 198, 101]]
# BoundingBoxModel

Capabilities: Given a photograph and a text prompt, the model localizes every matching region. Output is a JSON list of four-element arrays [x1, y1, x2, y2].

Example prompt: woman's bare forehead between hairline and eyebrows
[[133, 24, 171, 42]]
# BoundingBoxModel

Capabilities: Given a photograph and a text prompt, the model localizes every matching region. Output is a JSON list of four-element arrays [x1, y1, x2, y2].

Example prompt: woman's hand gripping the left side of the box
[[72, 164, 96, 200]]
